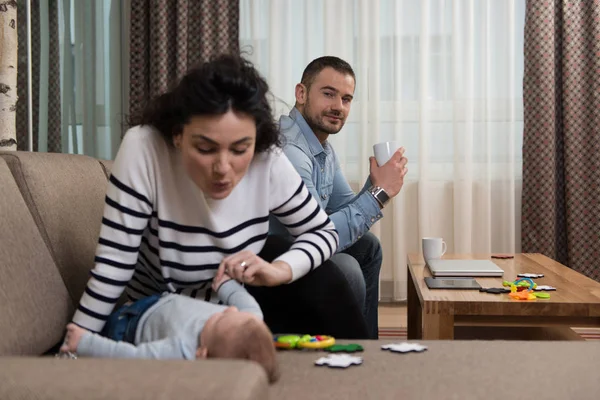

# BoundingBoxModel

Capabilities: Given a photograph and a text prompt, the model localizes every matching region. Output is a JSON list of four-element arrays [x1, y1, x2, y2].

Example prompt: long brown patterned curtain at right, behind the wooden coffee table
[[522, 0, 600, 281]]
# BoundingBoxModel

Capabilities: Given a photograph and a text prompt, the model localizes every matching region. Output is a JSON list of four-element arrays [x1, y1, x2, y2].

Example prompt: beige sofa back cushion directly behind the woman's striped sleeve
[[1, 152, 108, 303]]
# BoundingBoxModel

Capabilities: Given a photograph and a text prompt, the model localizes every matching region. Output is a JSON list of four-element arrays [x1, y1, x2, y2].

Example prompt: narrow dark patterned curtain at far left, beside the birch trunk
[[16, 0, 62, 152]]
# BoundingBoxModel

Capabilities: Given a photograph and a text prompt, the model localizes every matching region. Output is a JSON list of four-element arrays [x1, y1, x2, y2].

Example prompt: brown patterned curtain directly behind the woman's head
[[129, 0, 239, 121]]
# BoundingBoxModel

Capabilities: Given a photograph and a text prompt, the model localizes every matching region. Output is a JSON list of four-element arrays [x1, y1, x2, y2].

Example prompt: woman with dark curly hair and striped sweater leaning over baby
[[73, 56, 367, 354]]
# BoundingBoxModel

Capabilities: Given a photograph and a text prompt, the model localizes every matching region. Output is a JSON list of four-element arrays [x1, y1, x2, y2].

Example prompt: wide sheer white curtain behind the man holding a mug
[[240, 0, 525, 300]]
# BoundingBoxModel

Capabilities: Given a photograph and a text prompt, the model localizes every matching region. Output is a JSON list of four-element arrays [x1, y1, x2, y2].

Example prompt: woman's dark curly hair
[[130, 55, 281, 153]]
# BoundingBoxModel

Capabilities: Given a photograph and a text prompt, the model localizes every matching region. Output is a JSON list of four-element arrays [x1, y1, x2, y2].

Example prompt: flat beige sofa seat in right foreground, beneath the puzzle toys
[[270, 340, 600, 400]]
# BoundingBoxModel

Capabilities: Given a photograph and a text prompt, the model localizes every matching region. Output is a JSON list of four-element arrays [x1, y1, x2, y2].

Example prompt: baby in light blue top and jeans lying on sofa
[[60, 276, 279, 382]]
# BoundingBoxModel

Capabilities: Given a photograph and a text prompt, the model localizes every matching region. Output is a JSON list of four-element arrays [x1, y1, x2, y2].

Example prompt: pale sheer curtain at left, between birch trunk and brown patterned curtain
[[55, 0, 129, 159]]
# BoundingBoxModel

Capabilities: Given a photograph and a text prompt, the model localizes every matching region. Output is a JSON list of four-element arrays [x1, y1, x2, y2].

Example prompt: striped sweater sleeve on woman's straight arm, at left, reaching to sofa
[[73, 127, 155, 332]]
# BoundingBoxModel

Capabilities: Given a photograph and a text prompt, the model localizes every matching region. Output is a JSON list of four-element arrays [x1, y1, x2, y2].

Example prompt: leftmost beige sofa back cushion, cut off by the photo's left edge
[[0, 158, 74, 355]]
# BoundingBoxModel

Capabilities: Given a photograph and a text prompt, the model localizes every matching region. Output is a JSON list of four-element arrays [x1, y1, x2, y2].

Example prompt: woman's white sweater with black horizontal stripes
[[73, 126, 338, 332]]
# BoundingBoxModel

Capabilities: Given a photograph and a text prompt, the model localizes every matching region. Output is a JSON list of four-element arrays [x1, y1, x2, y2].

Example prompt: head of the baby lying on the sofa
[[196, 307, 279, 382]]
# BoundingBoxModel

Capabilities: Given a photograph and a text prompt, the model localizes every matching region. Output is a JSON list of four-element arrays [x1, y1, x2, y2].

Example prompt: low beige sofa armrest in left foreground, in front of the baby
[[0, 357, 268, 400]]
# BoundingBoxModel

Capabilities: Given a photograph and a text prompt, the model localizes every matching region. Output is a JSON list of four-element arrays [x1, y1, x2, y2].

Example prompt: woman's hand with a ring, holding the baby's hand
[[214, 250, 292, 286]]
